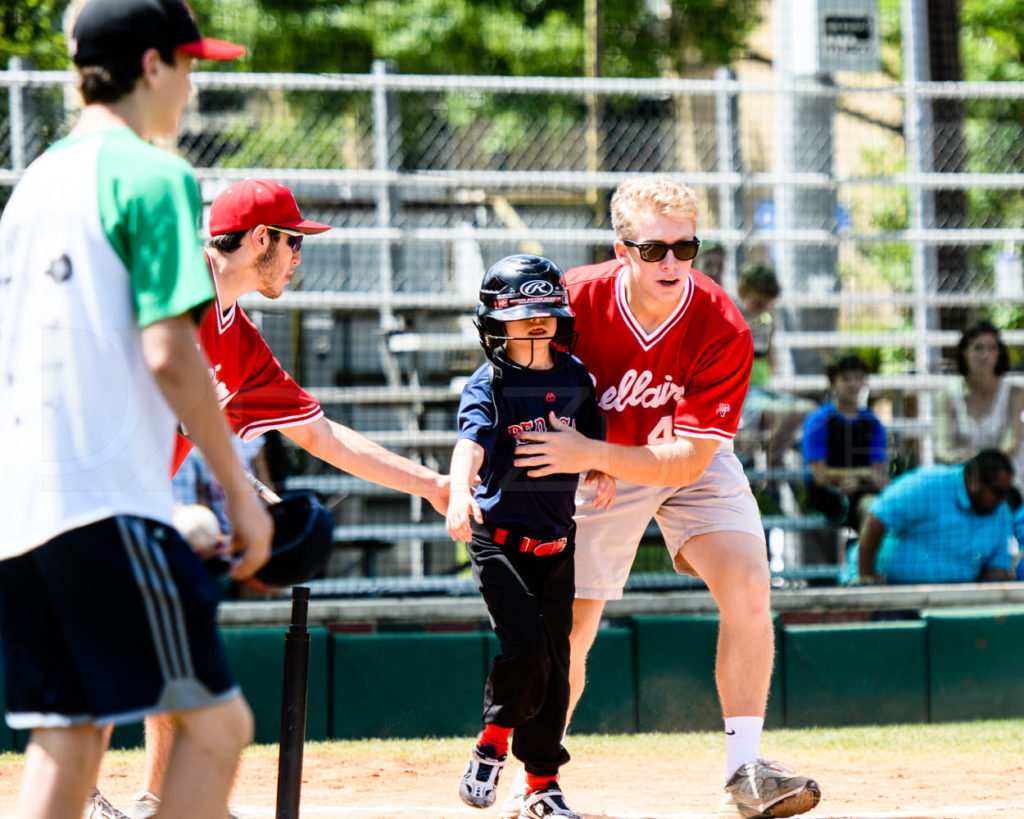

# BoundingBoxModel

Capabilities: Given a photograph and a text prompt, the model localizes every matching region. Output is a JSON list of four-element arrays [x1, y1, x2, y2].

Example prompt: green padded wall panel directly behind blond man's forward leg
[[633, 614, 784, 732]]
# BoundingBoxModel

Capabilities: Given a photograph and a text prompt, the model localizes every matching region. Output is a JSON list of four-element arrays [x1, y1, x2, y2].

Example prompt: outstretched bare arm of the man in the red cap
[[281, 417, 449, 515]]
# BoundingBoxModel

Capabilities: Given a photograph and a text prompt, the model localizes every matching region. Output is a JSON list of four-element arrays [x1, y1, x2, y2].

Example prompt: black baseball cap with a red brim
[[70, 0, 246, 66]]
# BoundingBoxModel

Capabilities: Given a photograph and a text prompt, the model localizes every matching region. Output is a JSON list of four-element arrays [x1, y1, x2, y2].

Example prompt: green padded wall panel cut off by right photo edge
[[921, 606, 1024, 722]]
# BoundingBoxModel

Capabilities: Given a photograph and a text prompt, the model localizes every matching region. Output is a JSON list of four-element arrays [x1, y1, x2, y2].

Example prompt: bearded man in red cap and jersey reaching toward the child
[[101, 179, 449, 819]]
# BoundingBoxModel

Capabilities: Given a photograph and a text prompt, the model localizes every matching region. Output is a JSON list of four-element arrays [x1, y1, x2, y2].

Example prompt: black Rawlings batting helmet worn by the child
[[473, 253, 577, 361]]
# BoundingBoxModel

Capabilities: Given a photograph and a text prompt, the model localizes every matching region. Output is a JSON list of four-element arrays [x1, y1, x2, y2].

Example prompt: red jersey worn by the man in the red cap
[[171, 257, 324, 475]]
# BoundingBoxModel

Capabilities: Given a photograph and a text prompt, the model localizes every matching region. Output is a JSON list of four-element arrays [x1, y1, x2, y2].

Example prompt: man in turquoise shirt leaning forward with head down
[[850, 449, 1024, 584]]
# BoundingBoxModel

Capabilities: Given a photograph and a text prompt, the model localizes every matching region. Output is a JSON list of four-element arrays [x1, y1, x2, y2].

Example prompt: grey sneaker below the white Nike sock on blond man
[[718, 760, 821, 819]]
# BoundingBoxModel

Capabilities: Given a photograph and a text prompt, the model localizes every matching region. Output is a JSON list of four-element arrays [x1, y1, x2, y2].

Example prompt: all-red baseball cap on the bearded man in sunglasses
[[210, 177, 331, 236]]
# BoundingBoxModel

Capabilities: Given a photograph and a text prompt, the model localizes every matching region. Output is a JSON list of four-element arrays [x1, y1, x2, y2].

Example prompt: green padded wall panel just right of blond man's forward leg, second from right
[[780, 621, 928, 728]]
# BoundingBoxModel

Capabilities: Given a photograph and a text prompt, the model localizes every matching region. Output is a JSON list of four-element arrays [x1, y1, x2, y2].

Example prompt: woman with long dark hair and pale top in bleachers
[[935, 320, 1024, 480]]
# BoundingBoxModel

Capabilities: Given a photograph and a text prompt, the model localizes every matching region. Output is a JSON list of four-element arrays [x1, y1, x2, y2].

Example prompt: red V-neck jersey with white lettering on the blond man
[[565, 259, 754, 448]]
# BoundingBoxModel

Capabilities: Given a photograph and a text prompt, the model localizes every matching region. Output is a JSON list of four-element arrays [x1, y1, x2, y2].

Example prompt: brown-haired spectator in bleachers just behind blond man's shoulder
[[736, 264, 814, 469]]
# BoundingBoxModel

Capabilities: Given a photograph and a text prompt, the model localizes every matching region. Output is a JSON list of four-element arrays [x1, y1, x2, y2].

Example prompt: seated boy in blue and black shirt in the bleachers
[[802, 354, 888, 529]]
